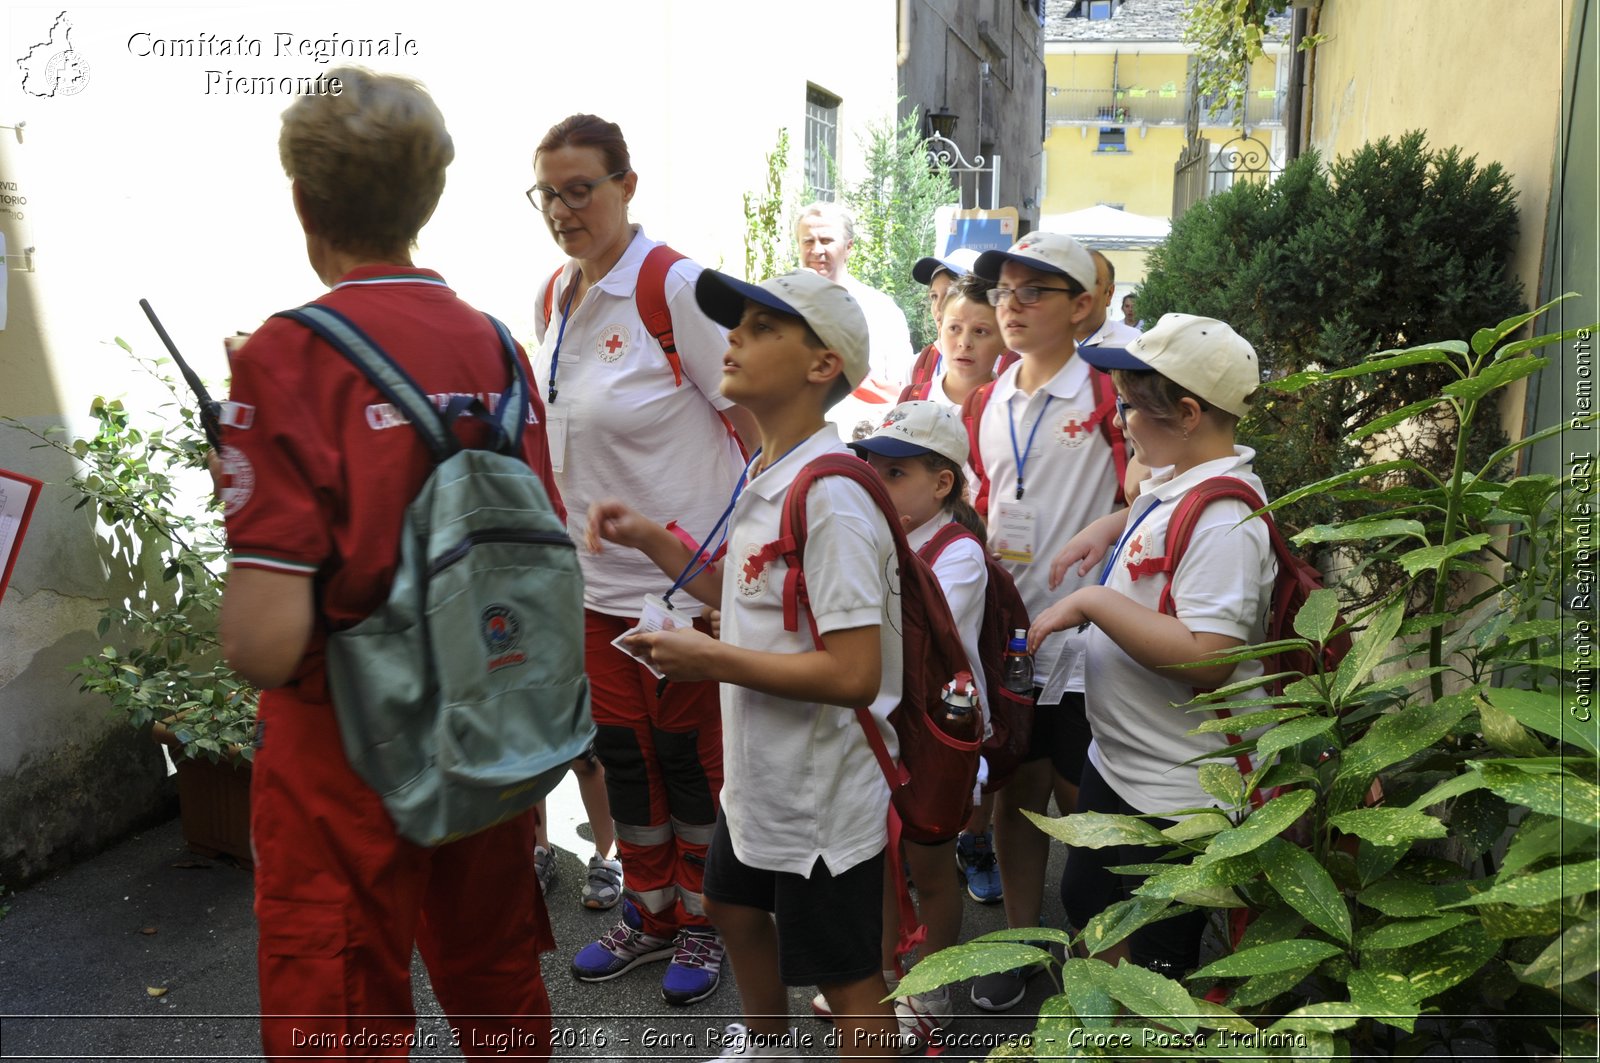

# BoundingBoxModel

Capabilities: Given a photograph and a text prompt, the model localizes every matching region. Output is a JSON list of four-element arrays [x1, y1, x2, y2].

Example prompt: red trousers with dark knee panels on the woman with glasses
[[584, 612, 722, 937]]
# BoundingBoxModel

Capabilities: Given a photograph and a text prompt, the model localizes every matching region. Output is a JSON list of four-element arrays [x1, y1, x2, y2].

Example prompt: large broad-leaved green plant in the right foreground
[[899, 304, 1600, 1060]]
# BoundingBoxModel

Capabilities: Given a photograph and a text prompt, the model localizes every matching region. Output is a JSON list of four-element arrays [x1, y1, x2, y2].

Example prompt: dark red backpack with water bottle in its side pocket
[[917, 520, 1034, 794]]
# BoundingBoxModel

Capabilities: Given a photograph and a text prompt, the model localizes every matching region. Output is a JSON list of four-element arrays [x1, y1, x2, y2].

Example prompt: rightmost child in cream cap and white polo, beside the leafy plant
[[1029, 314, 1277, 978]]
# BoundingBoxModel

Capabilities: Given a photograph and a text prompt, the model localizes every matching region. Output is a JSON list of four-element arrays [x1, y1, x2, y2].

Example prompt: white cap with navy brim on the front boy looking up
[[694, 269, 867, 387]]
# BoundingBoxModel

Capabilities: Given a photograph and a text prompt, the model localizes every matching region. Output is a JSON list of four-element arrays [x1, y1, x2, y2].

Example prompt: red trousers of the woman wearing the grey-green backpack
[[250, 690, 555, 1060]]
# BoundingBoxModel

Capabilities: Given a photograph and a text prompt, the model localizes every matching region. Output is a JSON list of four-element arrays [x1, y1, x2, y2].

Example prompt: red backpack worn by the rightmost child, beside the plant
[[1134, 475, 1350, 807]]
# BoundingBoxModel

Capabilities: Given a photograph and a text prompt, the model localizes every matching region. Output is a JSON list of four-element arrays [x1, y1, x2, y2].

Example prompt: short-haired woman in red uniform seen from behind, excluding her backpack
[[216, 69, 562, 1060]]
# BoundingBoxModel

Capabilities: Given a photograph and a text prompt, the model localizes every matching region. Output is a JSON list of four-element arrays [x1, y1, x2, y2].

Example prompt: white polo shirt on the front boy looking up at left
[[722, 424, 904, 876]]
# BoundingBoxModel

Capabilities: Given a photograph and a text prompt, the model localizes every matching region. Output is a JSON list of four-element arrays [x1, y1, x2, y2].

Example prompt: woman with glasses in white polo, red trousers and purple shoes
[[528, 114, 755, 1005]]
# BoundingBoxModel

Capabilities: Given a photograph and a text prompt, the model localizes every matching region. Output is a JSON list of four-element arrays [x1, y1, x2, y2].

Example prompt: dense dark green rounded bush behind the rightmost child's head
[[1138, 133, 1526, 557]]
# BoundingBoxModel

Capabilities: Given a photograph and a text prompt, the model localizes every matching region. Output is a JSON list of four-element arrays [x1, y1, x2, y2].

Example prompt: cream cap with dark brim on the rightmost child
[[1078, 314, 1261, 416]]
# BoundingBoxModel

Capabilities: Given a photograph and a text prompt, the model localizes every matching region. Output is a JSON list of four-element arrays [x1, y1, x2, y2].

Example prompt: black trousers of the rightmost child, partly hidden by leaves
[[1061, 760, 1206, 978]]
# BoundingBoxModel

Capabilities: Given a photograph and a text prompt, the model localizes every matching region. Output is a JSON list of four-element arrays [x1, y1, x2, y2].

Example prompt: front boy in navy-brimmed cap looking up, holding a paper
[[589, 271, 902, 1058]]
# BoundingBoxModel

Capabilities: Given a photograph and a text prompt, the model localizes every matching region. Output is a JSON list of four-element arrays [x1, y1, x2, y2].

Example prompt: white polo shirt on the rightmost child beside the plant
[[1085, 447, 1278, 813]]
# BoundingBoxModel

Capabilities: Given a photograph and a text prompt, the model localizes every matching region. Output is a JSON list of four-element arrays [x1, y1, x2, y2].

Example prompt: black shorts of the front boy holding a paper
[[701, 812, 883, 986]]
